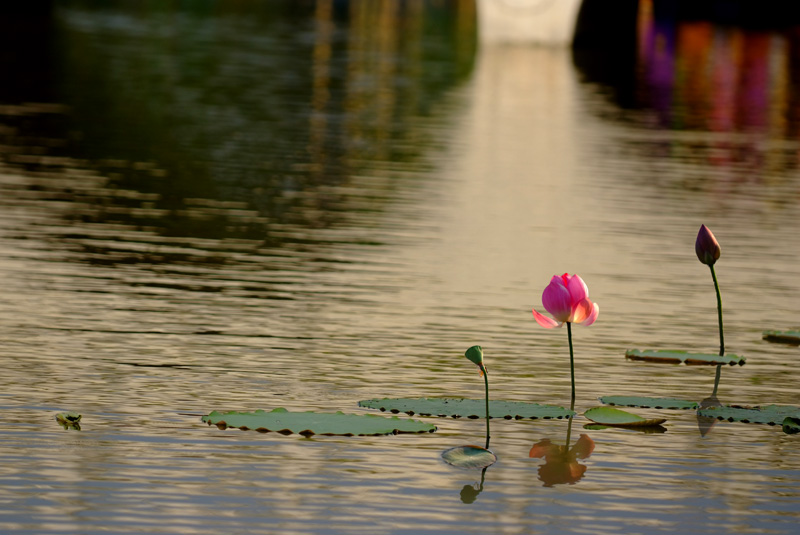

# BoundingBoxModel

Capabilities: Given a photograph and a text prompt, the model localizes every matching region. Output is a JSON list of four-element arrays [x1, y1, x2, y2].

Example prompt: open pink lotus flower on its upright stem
[[533, 273, 600, 329]]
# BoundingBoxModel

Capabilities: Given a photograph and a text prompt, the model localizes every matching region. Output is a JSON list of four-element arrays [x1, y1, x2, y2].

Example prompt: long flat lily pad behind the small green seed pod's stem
[[358, 398, 575, 420]]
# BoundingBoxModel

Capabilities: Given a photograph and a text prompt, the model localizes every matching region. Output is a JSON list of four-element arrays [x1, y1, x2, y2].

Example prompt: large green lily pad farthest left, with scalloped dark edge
[[202, 408, 436, 437]]
